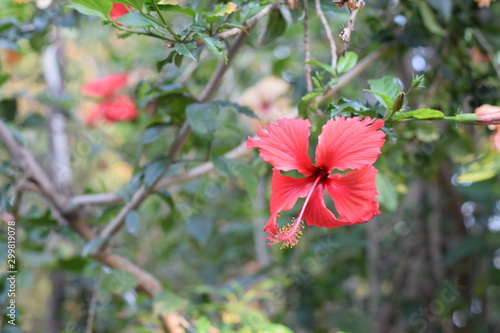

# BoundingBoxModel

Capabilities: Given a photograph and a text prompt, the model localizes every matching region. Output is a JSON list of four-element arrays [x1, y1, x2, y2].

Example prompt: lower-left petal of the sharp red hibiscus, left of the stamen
[[264, 169, 314, 237]]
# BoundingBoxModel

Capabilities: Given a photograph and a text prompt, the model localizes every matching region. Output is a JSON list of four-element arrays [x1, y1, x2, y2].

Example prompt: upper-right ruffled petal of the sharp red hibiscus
[[316, 117, 385, 173]]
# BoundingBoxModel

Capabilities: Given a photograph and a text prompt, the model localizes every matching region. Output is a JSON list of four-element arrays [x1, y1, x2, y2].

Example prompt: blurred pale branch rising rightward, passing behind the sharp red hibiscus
[[71, 44, 393, 207]]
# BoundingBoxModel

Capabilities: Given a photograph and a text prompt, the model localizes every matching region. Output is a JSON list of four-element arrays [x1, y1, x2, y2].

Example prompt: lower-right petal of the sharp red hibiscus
[[326, 165, 380, 223]]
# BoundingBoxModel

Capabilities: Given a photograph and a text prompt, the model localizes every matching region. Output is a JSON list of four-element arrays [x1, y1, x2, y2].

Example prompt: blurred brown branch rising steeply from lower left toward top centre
[[94, 34, 247, 250]]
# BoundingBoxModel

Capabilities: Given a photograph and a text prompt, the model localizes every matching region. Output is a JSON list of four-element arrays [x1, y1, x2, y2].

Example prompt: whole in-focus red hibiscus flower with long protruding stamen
[[247, 117, 385, 247]]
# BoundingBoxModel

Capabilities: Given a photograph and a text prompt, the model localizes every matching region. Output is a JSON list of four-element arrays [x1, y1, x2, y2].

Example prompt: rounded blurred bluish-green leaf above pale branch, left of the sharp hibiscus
[[186, 103, 220, 136]]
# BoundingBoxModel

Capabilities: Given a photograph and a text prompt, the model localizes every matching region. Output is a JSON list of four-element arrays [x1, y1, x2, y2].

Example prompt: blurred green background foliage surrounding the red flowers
[[0, 0, 500, 333]]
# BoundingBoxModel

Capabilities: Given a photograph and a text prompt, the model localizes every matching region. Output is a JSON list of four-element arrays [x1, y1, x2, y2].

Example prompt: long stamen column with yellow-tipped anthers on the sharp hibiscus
[[264, 172, 324, 249]]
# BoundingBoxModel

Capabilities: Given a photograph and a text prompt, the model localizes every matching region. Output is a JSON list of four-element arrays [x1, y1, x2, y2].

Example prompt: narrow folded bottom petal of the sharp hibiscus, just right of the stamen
[[302, 183, 353, 228]]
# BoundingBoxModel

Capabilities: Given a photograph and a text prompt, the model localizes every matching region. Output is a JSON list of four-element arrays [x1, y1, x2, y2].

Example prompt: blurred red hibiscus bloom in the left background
[[82, 74, 137, 125]]
